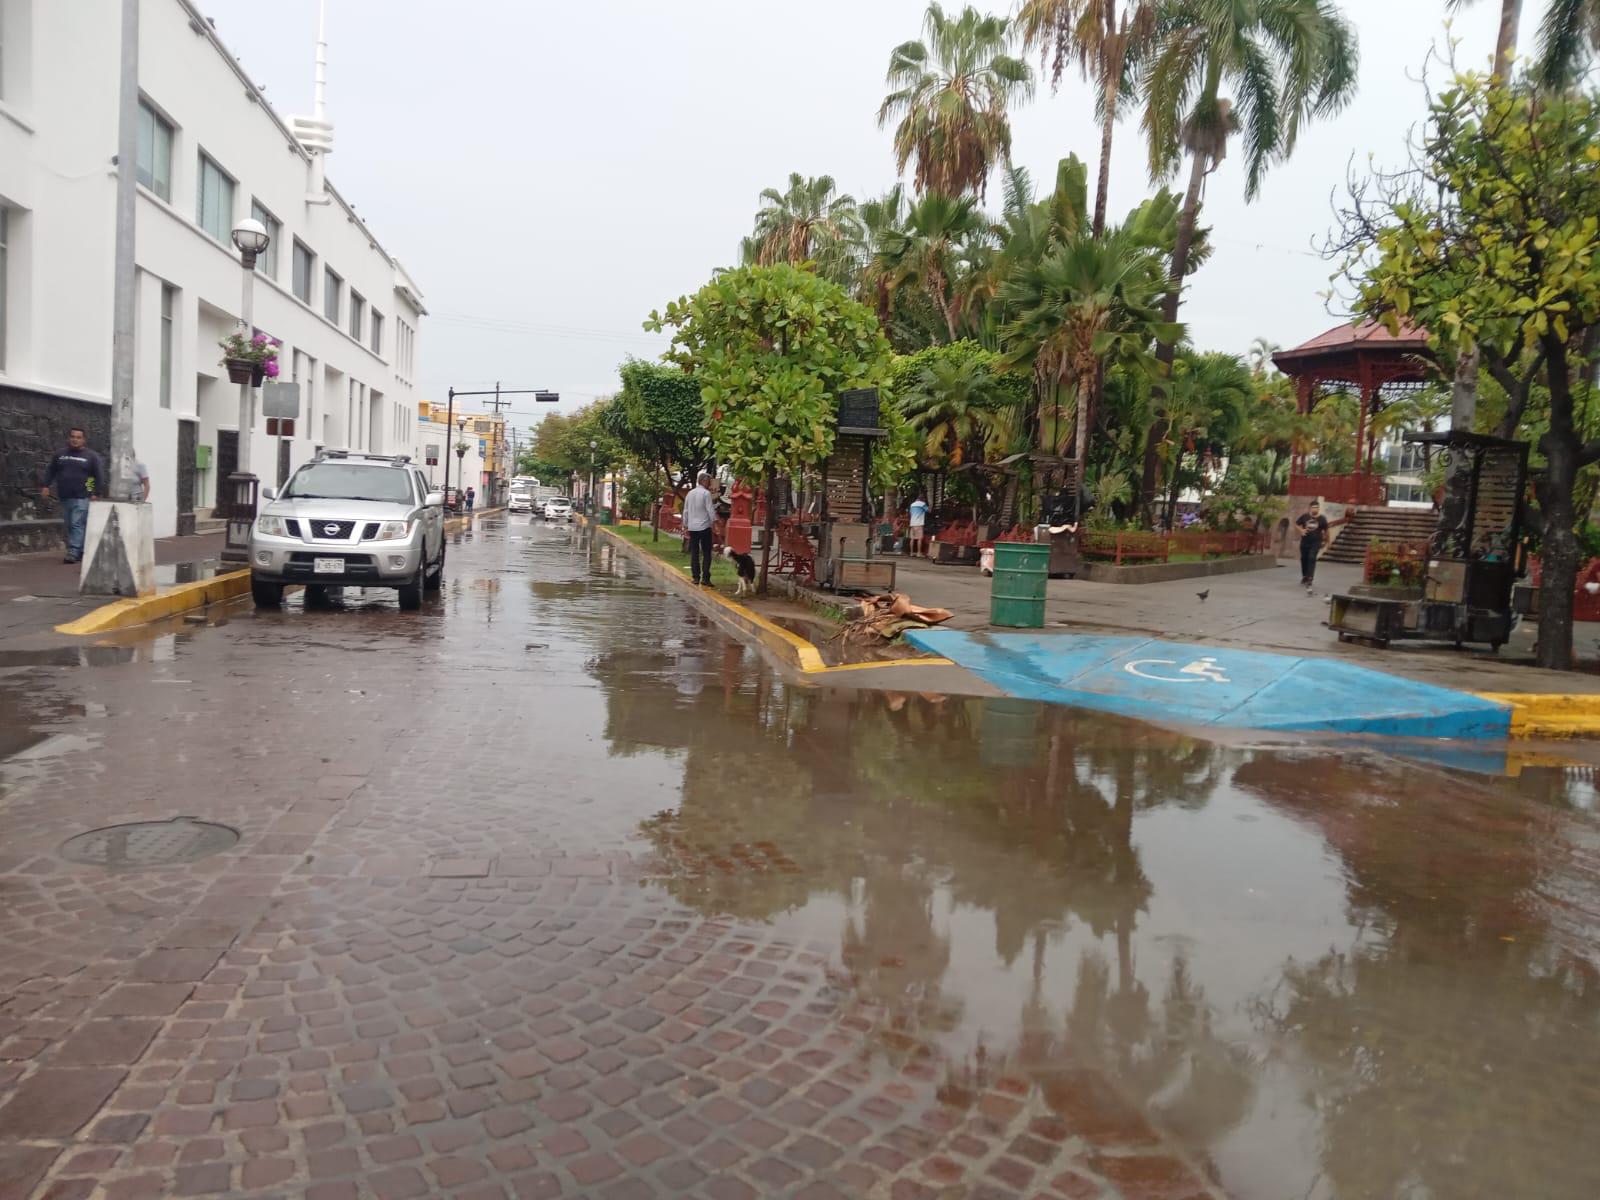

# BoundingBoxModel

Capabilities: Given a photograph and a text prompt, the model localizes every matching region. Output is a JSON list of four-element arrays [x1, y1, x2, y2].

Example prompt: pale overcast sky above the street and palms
[[200, 0, 1523, 438]]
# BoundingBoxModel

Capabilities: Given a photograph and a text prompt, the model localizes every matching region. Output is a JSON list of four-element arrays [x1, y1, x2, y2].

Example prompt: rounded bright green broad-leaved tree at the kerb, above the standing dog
[[645, 262, 914, 598]]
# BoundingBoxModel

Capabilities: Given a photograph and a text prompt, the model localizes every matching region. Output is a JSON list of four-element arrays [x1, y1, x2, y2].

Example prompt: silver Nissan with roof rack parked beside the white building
[[250, 451, 445, 610]]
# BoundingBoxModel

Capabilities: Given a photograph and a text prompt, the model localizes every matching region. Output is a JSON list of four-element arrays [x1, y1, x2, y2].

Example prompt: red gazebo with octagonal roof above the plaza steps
[[1272, 322, 1434, 506]]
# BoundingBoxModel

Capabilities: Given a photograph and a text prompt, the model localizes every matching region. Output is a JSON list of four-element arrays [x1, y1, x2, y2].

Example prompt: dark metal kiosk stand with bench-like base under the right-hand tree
[[1328, 432, 1528, 650]]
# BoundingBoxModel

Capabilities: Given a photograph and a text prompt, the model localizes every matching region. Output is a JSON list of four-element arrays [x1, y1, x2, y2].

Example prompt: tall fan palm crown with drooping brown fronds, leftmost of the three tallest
[[878, 3, 1034, 195]]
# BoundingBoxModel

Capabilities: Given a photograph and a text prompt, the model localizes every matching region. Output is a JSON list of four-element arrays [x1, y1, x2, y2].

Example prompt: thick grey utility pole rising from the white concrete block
[[108, 0, 139, 501]]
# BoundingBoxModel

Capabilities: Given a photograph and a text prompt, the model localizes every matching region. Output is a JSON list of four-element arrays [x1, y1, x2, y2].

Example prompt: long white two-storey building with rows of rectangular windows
[[0, 0, 426, 536]]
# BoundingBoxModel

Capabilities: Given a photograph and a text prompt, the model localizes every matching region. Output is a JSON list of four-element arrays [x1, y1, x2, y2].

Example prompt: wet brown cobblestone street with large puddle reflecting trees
[[0, 517, 1600, 1200]]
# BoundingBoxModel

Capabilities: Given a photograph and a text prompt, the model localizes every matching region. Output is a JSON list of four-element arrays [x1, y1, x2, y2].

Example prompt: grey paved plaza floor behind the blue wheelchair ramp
[[894, 558, 1600, 694]]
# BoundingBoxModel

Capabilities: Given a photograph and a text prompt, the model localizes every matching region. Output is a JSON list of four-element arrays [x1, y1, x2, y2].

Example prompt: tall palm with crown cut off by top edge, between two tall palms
[[1016, 0, 1160, 234]]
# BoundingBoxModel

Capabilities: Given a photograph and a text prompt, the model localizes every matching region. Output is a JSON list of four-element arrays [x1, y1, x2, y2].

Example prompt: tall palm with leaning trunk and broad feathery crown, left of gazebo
[[1142, 0, 1357, 518]]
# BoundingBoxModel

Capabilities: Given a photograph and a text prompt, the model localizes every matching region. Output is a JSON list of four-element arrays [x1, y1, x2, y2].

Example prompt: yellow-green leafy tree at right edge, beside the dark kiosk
[[1344, 74, 1600, 669]]
